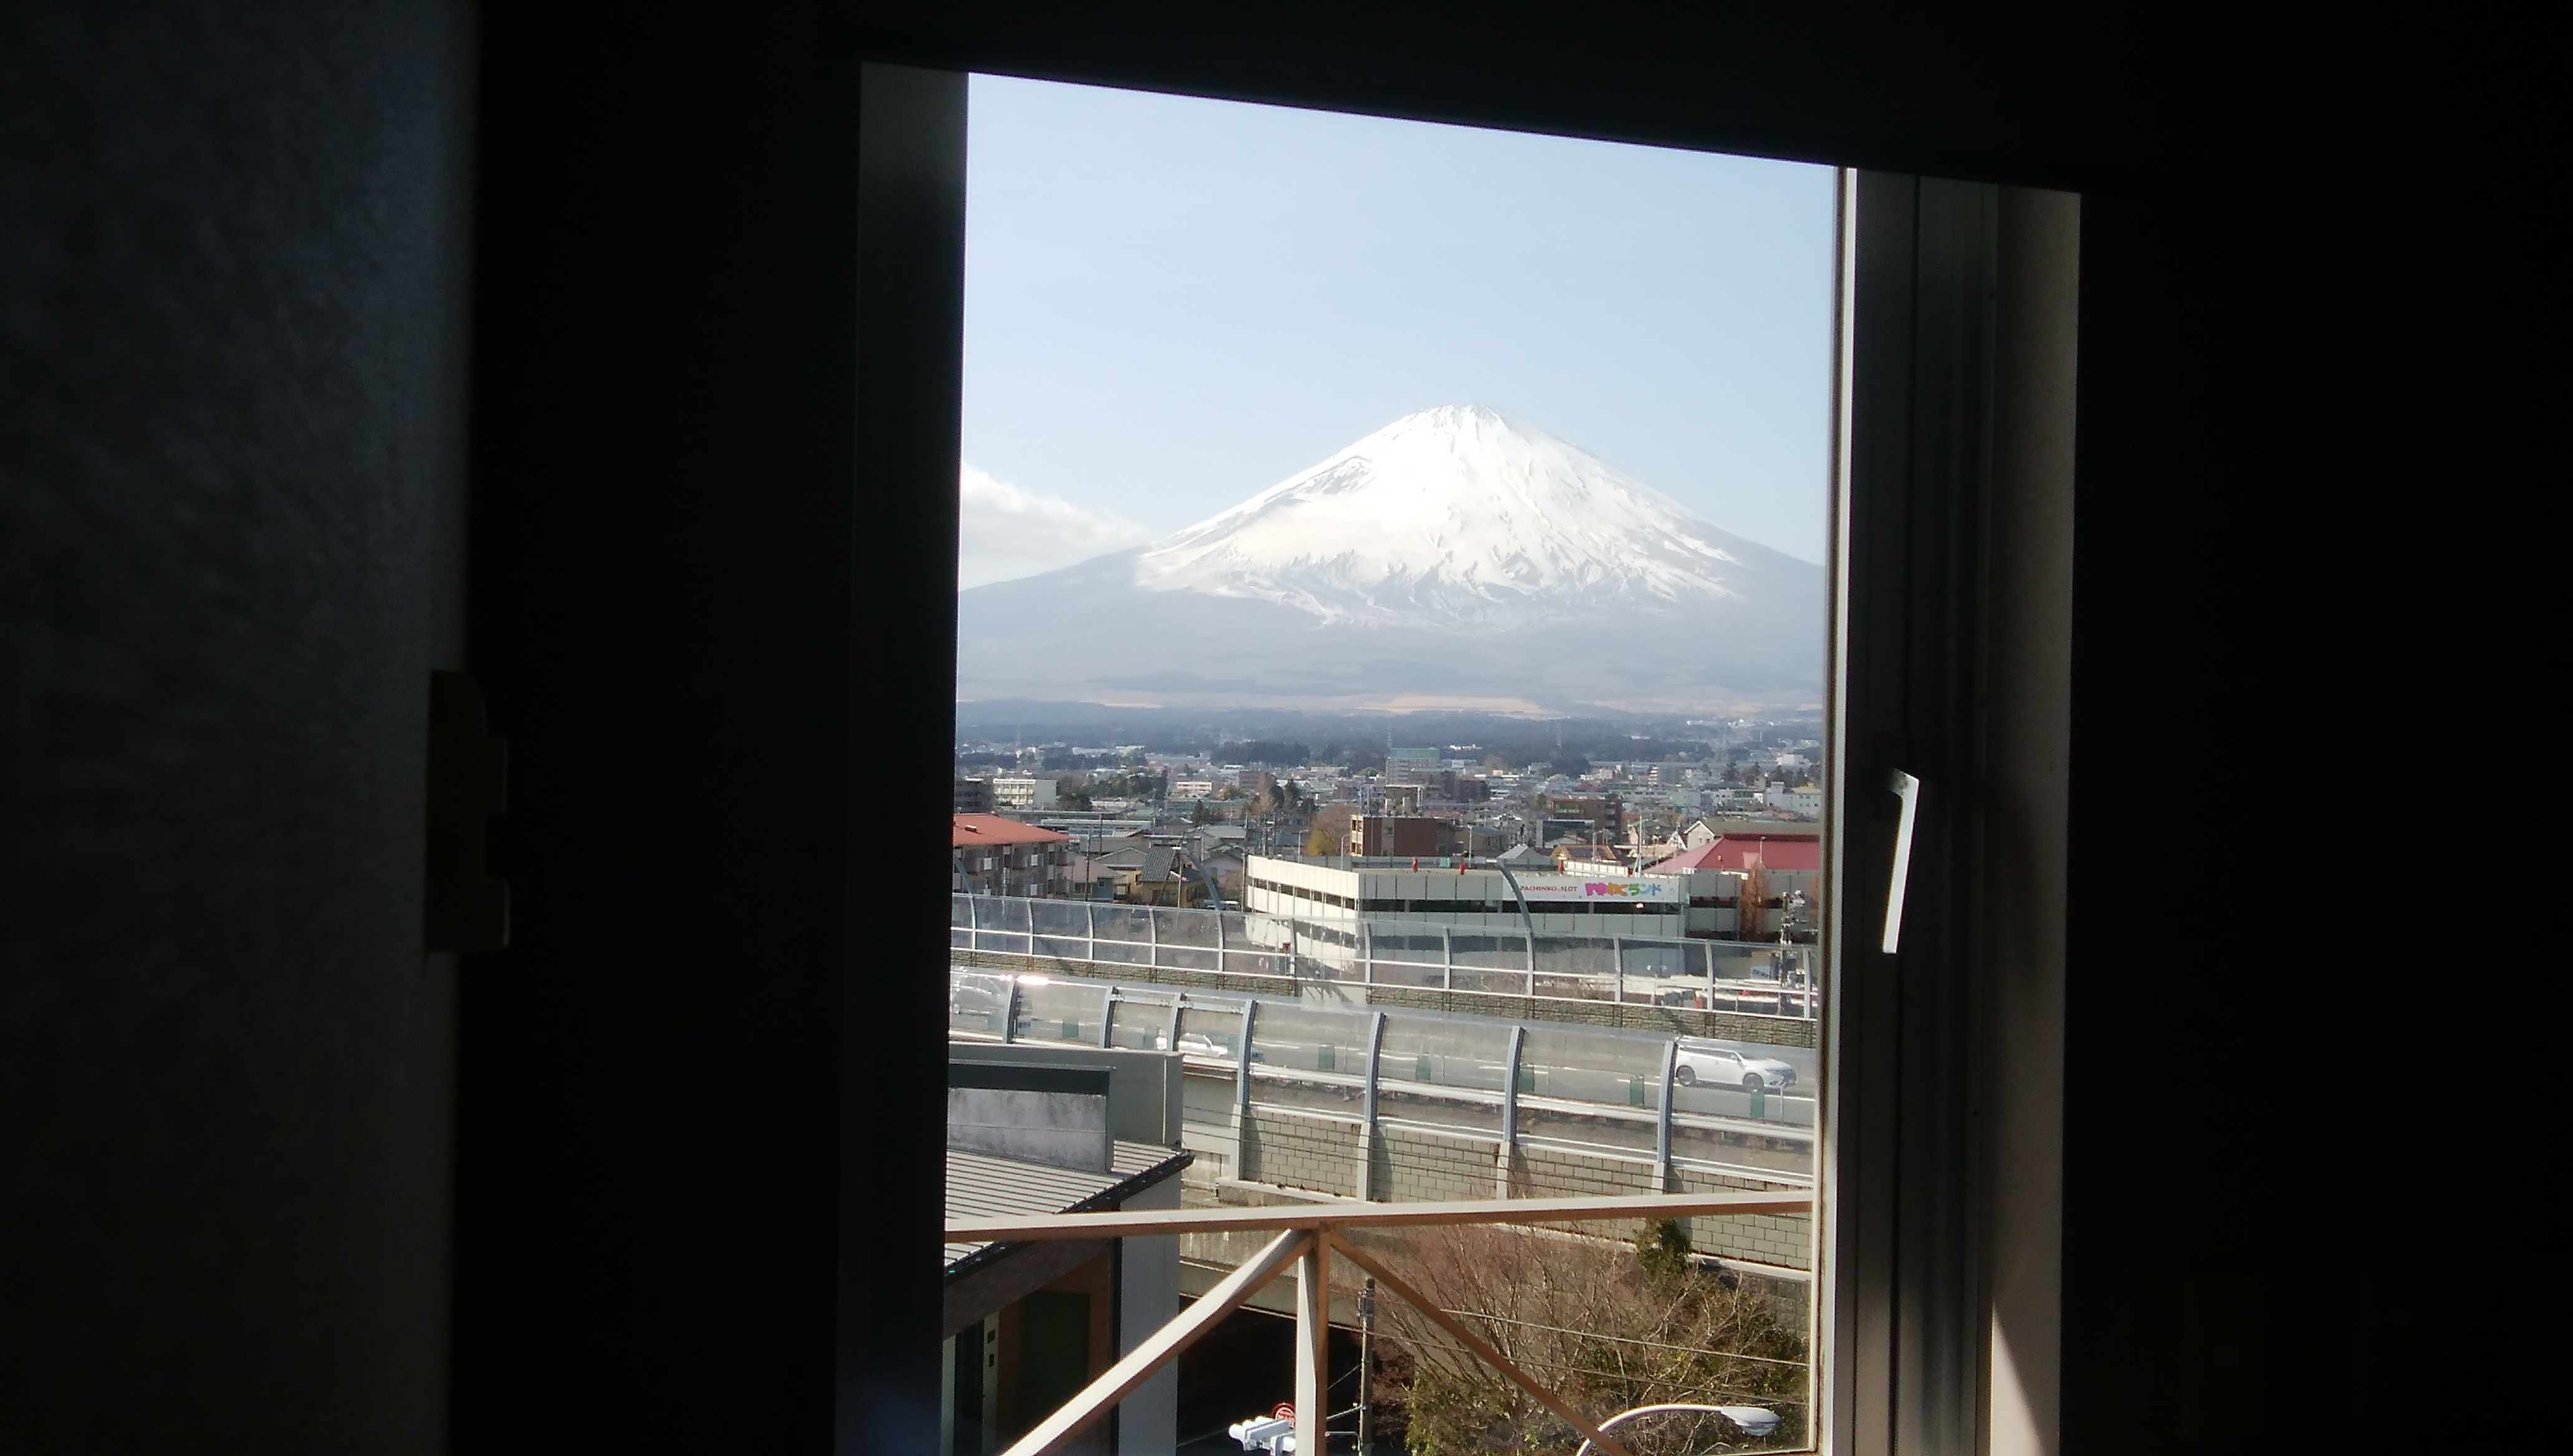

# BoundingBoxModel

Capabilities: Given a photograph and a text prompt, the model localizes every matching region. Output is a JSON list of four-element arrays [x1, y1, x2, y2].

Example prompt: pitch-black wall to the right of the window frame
[[2064, 178, 2560, 1454]]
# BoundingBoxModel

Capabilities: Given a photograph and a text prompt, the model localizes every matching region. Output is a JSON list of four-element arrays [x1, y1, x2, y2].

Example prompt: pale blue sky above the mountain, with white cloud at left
[[962, 77, 1832, 587]]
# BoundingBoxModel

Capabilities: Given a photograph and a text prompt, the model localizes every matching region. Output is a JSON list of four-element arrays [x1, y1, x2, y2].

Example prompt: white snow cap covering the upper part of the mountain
[[1134, 404, 1760, 628]]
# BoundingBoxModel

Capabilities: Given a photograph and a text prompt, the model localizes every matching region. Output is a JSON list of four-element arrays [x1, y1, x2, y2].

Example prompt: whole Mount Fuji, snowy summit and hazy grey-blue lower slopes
[[957, 404, 1824, 712]]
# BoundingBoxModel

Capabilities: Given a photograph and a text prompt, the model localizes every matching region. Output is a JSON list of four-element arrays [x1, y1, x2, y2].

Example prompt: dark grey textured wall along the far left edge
[[0, 0, 466, 1454]]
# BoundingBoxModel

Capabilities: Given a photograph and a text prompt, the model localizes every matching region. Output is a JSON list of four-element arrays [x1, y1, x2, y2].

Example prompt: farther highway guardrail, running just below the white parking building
[[947, 895, 1822, 1022]]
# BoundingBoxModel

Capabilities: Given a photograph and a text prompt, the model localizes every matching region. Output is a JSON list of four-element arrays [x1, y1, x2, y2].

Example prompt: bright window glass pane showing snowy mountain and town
[[949, 77, 1834, 1456]]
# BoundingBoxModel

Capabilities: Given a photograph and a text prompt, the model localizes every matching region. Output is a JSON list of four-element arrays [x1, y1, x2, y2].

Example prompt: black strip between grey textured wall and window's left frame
[[456, 5, 865, 1451]]
